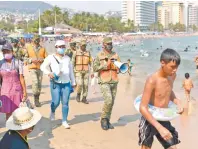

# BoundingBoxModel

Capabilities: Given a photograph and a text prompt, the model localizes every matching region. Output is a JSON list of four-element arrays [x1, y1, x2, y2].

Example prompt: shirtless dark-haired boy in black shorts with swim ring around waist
[[139, 49, 183, 149]]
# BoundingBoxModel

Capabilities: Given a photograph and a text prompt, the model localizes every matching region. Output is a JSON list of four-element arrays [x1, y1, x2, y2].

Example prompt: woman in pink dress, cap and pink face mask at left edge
[[0, 43, 27, 120]]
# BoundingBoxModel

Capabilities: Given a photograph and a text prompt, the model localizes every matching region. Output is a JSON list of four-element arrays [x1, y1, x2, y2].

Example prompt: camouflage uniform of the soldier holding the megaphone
[[93, 38, 120, 130]]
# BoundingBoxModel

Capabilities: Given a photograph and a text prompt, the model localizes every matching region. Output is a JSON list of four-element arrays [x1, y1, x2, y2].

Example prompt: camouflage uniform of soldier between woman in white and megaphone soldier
[[72, 40, 92, 104]]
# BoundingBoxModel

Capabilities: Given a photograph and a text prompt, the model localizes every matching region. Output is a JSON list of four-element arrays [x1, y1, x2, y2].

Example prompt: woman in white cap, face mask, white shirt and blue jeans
[[41, 40, 76, 129]]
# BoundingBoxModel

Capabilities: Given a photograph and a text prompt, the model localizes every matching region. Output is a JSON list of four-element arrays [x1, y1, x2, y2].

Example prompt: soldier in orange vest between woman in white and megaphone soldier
[[72, 40, 92, 104]]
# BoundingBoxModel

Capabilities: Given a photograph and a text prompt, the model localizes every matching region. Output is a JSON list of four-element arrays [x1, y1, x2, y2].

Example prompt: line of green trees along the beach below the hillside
[[0, 6, 198, 33]]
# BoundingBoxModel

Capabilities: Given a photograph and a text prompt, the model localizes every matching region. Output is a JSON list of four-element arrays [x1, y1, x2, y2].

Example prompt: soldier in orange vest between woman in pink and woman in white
[[25, 36, 47, 107]]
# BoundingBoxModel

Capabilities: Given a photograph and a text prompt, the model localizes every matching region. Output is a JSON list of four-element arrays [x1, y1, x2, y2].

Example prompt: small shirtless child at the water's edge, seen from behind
[[183, 73, 193, 102]]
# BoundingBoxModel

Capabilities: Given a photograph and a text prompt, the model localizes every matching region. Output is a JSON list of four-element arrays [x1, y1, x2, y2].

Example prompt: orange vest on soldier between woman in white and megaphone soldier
[[75, 51, 90, 71]]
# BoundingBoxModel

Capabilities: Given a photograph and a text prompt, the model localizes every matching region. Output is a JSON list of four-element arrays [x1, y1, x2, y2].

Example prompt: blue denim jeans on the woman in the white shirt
[[50, 81, 71, 122]]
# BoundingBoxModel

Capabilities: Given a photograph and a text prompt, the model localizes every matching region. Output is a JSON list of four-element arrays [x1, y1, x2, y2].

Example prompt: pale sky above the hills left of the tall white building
[[45, 1, 122, 14]]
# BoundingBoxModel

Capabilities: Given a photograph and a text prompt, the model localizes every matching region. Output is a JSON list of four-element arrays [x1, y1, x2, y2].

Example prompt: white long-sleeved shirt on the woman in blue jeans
[[41, 54, 76, 86]]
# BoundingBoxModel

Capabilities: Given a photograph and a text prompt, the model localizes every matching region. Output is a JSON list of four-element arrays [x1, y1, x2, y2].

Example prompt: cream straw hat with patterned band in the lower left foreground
[[6, 107, 41, 130]]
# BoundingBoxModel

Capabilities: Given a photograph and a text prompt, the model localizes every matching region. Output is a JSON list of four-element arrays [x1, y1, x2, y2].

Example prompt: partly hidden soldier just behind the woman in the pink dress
[[12, 39, 24, 61]]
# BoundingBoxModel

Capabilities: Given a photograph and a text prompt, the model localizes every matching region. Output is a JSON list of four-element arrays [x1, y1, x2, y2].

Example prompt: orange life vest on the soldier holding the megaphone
[[98, 51, 118, 83]]
